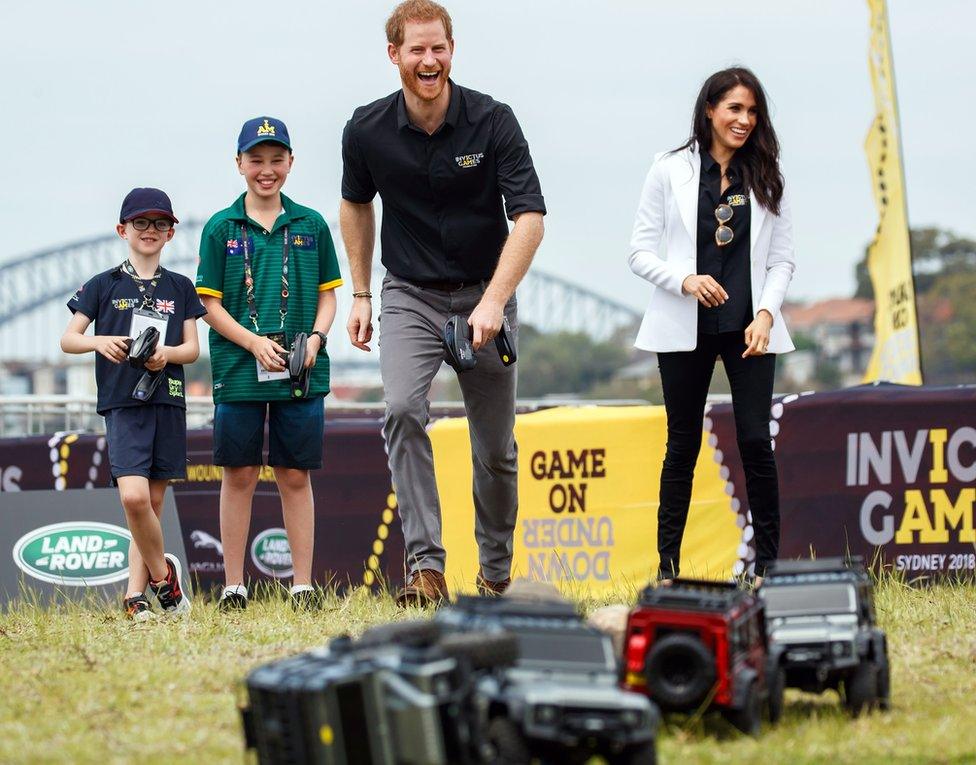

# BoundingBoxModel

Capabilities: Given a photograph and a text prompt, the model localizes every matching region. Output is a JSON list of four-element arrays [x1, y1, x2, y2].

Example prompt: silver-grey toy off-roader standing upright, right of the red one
[[759, 557, 891, 717]]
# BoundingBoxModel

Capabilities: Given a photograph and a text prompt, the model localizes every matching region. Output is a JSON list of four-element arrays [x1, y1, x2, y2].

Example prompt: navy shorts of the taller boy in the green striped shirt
[[214, 396, 325, 470]]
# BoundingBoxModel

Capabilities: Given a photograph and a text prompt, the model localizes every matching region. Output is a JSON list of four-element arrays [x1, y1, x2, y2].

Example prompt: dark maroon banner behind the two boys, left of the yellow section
[[0, 413, 403, 588]]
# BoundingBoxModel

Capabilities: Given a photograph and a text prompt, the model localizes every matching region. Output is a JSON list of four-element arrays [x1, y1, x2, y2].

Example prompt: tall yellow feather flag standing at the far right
[[864, 0, 922, 385]]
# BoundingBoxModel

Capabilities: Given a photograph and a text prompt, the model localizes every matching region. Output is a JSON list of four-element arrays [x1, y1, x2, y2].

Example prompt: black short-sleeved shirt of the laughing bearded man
[[342, 81, 546, 283]]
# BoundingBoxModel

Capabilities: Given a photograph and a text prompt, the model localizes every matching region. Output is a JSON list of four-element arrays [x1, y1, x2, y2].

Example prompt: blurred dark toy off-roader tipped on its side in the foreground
[[241, 621, 518, 765]]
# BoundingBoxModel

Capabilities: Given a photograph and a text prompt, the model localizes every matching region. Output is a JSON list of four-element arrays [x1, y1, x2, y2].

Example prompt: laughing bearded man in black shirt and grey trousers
[[339, 0, 546, 604]]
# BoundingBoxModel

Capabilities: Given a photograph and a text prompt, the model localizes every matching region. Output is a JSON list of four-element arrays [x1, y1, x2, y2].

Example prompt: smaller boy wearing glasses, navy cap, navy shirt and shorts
[[61, 188, 206, 622]]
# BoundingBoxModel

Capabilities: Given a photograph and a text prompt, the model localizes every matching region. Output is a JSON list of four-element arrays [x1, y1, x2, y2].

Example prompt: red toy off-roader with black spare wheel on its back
[[624, 579, 784, 735]]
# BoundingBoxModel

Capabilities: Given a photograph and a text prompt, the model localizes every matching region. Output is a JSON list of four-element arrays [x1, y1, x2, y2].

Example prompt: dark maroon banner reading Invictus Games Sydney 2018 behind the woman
[[709, 385, 976, 580]]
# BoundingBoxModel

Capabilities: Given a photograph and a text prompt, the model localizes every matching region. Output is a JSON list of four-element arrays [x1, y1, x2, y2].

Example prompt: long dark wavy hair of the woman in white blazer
[[675, 66, 783, 215]]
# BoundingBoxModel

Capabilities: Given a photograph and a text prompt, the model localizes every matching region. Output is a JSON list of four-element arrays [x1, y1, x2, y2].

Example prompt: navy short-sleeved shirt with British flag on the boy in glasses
[[68, 266, 207, 414]]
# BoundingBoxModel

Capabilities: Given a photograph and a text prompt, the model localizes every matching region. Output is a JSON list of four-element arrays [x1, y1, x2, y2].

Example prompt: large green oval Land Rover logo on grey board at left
[[13, 521, 132, 587]]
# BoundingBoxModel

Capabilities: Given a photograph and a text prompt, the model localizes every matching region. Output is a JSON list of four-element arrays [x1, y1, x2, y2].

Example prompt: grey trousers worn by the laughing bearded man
[[379, 274, 518, 581]]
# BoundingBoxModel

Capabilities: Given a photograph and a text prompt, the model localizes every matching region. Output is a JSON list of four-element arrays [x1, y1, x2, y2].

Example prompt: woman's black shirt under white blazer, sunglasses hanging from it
[[698, 151, 752, 335]]
